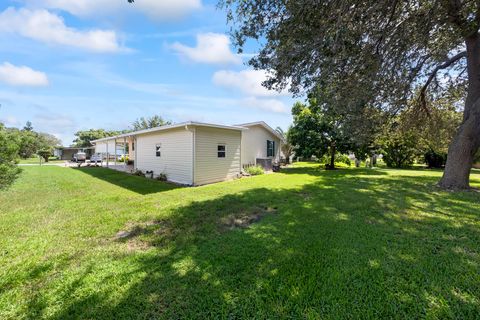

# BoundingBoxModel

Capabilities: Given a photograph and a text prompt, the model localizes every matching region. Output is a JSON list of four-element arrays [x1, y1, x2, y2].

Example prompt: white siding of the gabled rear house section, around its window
[[242, 125, 280, 165]]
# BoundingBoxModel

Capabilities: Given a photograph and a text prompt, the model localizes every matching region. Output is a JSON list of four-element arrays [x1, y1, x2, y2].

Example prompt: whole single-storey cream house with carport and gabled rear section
[[92, 121, 281, 185]]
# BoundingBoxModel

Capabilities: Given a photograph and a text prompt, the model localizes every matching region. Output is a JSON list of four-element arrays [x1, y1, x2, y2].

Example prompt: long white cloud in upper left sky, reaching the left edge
[[0, 8, 125, 52]]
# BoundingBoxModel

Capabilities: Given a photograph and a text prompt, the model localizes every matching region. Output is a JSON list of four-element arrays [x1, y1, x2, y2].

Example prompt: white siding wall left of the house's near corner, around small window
[[135, 127, 193, 185]]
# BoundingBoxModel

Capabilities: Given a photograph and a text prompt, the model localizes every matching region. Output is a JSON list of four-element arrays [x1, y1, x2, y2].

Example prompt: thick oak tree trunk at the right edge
[[439, 34, 480, 190]]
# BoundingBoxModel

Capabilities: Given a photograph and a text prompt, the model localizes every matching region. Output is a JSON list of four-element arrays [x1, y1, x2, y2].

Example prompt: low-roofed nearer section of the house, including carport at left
[[92, 122, 246, 185]]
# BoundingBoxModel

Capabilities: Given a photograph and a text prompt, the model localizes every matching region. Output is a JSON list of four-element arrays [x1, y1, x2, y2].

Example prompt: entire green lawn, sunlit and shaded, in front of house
[[0, 164, 480, 319]]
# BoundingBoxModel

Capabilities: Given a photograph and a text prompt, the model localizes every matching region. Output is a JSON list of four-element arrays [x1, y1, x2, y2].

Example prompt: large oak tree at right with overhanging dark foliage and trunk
[[220, 0, 480, 189]]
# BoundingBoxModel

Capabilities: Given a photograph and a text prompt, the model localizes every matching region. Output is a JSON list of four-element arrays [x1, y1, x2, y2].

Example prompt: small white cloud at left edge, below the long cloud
[[0, 62, 48, 87]]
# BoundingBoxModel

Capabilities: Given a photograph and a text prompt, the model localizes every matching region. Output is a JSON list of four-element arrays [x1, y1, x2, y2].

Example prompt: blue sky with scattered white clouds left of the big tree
[[0, 0, 294, 145]]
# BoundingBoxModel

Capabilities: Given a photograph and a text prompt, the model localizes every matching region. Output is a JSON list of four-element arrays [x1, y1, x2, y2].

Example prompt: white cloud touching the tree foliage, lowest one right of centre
[[213, 70, 287, 97]]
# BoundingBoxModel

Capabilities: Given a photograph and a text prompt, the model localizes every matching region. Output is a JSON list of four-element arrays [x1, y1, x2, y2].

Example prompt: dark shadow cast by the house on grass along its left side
[[74, 167, 180, 195]]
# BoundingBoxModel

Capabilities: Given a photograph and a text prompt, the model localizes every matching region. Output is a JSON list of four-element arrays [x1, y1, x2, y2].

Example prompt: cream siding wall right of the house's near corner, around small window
[[195, 127, 242, 185]]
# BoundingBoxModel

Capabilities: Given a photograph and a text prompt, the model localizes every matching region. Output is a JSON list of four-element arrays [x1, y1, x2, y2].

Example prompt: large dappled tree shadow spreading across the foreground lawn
[[29, 170, 480, 319]]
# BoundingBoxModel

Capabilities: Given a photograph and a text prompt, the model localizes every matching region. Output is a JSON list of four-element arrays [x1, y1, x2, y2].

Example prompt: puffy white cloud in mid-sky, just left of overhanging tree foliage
[[171, 33, 242, 64]]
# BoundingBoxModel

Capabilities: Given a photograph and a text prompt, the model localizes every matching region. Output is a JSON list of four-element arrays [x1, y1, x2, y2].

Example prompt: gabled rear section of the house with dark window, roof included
[[237, 121, 283, 169]]
